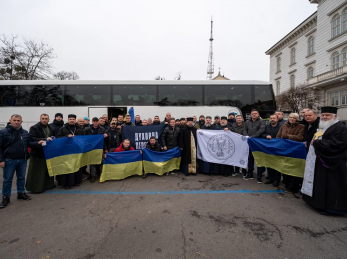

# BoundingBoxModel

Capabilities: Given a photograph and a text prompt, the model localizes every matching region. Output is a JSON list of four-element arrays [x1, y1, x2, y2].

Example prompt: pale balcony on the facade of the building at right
[[307, 66, 347, 87]]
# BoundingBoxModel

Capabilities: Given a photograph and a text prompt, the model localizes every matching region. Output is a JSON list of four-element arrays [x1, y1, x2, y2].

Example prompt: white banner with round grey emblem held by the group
[[196, 130, 249, 168]]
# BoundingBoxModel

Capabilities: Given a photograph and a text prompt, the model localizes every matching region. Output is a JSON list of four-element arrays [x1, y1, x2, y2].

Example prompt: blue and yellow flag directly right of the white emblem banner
[[248, 138, 306, 178]]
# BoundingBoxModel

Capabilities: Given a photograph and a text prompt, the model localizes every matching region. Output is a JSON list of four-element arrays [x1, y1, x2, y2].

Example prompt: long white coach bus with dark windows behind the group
[[0, 80, 276, 129]]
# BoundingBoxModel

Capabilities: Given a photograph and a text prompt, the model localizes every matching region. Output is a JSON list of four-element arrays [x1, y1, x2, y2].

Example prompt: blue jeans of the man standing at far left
[[2, 158, 27, 197]]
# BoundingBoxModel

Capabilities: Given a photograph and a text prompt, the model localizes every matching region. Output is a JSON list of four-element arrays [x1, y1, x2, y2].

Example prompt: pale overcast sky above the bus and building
[[0, 0, 317, 80]]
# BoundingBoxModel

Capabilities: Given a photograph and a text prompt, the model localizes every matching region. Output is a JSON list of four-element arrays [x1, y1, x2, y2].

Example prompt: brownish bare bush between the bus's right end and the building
[[276, 84, 323, 113]]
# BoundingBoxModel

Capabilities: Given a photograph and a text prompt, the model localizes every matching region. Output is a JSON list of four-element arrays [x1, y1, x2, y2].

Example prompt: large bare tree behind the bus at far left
[[0, 35, 56, 80]]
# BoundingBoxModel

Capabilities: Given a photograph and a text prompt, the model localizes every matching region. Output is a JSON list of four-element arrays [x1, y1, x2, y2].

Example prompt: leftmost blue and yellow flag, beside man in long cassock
[[43, 135, 104, 176]]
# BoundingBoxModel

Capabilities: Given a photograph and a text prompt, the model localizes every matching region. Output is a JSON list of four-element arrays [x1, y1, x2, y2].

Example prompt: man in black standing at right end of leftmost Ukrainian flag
[[85, 117, 110, 183]]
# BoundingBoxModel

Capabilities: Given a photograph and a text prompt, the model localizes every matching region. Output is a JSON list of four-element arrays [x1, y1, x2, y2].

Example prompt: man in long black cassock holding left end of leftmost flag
[[26, 114, 55, 193]]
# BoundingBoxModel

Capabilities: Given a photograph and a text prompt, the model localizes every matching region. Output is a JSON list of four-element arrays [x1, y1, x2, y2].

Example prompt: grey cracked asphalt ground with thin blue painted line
[[0, 171, 347, 259]]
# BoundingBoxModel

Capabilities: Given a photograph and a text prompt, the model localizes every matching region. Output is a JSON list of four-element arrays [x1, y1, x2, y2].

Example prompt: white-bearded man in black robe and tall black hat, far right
[[303, 106, 347, 215]]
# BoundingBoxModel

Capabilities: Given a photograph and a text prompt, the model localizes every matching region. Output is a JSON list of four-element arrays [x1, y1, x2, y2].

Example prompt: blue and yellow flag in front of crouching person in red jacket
[[100, 150, 142, 183]]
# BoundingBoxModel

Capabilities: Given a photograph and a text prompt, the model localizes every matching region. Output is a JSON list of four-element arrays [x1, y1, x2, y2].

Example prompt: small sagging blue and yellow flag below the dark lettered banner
[[143, 147, 182, 175]]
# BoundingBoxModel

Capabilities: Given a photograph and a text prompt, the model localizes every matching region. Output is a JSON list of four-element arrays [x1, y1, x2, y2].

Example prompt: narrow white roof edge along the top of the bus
[[0, 80, 271, 85]]
